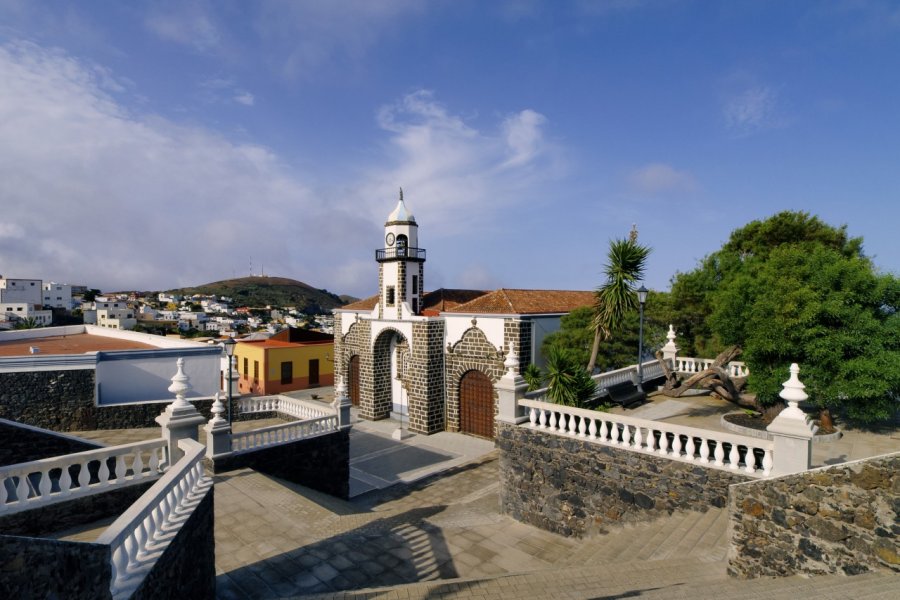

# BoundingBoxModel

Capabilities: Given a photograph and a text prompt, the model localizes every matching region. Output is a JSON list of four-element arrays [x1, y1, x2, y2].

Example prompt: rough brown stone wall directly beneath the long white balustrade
[[497, 423, 749, 537]]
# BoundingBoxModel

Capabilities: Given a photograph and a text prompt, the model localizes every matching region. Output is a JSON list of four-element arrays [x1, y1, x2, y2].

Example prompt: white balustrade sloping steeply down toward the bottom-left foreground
[[97, 439, 212, 599]]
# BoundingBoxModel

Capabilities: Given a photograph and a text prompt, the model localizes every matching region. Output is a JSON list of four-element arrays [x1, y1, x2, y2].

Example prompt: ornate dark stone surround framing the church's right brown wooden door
[[444, 326, 505, 434]]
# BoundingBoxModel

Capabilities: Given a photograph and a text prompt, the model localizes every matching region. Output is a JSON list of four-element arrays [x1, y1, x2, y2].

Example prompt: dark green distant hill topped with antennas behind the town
[[169, 276, 346, 314]]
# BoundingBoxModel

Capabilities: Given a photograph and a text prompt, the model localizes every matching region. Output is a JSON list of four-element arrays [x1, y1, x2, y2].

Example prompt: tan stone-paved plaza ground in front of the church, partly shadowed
[[65, 395, 900, 600]]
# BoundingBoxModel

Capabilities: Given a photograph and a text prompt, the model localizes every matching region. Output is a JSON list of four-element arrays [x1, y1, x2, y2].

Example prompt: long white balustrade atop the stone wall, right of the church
[[519, 400, 774, 477]]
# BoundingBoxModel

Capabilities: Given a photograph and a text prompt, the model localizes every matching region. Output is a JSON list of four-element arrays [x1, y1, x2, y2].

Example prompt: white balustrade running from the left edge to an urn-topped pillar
[[0, 438, 166, 515]]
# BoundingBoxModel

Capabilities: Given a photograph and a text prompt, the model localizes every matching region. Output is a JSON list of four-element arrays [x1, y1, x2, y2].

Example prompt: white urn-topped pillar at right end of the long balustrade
[[766, 363, 818, 475]]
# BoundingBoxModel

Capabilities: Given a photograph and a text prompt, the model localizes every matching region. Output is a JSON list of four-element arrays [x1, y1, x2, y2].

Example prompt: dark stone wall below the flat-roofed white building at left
[[0, 369, 218, 431]]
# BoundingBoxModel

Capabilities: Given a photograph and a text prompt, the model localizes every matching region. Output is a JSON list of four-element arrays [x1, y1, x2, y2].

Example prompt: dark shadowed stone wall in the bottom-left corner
[[0, 535, 112, 600]]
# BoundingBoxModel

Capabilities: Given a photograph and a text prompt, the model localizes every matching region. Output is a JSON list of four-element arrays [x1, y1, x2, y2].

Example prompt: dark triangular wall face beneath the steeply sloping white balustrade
[[130, 486, 216, 600]]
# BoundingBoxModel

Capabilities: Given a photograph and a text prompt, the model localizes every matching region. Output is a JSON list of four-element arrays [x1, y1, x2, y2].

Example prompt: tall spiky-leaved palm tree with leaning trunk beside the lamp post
[[587, 237, 651, 373]]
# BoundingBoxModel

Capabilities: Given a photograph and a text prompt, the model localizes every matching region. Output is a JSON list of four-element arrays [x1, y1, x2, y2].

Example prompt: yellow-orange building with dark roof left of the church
[[234, 327, 334, 395]]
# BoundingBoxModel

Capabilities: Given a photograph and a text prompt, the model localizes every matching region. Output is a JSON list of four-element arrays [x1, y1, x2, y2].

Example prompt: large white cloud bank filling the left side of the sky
[[0, 43, 377, 293]]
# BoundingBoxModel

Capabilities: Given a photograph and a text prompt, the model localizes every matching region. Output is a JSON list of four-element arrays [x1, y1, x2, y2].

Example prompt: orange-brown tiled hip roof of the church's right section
[[444, 288, 594, 315]]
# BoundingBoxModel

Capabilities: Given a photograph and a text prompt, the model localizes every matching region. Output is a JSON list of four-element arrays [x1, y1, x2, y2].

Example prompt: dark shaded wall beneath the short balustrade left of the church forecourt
[[206, 430, 350, 498]]
